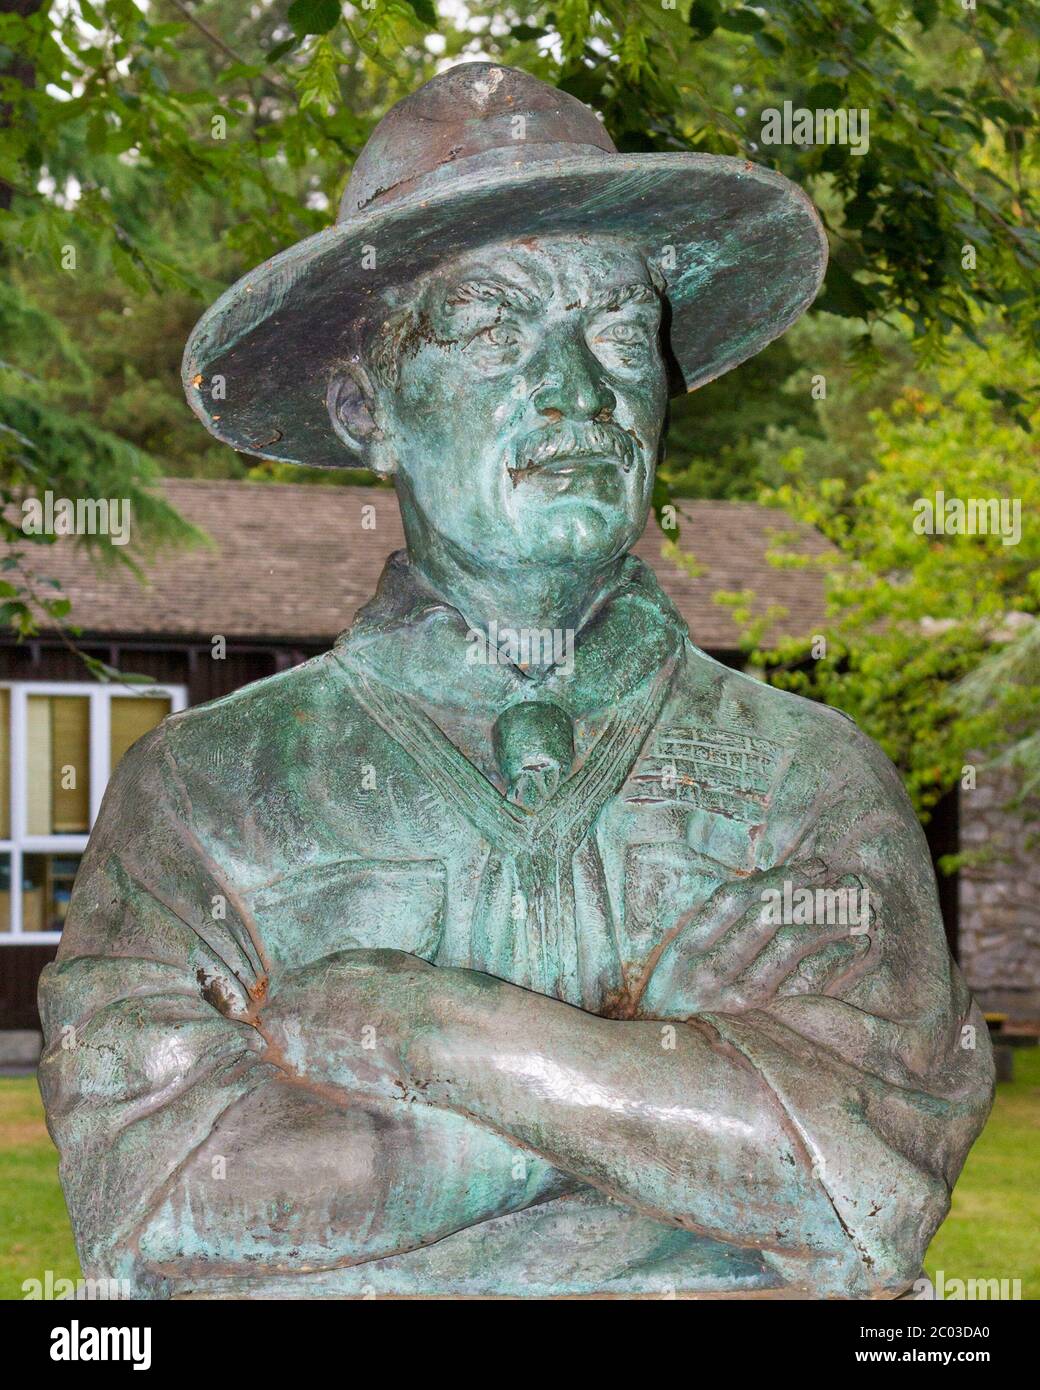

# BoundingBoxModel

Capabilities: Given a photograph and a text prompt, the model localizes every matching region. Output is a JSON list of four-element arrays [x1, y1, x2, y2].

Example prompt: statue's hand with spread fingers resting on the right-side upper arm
[[640, 862, 870, 1017]]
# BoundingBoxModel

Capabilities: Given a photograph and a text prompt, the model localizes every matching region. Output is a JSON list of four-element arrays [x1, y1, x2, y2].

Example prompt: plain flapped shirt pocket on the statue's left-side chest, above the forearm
[[252, 859, 445, 969]]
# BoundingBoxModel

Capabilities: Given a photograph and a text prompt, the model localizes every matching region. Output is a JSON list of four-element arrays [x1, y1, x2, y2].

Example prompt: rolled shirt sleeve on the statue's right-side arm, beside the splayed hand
[[704, 724, 993, 1293]]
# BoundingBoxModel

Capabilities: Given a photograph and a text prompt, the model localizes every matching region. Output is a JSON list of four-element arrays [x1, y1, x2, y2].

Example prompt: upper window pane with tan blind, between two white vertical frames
[[26, 695, 90, 835]]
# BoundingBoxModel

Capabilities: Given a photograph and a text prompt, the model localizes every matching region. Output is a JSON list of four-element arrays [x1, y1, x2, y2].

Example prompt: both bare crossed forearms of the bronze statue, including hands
[[119, 876, 878, 1275]]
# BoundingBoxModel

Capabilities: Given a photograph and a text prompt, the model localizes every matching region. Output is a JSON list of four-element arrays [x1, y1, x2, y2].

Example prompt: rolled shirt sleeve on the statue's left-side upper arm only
[[39, 728, 274, 1277]]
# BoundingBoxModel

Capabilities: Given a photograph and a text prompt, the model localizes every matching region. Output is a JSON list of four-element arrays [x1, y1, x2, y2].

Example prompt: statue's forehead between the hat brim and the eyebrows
[[422, 236, 651, 302]]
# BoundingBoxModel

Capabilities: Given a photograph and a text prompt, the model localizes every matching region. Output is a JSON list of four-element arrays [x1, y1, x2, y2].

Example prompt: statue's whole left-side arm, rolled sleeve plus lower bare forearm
[[39, 730, 570, 1297]]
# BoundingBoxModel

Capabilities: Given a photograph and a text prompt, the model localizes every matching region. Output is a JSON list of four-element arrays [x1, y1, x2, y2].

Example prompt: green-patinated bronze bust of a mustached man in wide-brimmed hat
[[40, 63, 993, 1298]]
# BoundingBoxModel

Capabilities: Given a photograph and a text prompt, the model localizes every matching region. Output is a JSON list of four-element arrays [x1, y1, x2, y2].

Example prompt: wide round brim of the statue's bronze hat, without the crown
[[182, 153, 827, 468]]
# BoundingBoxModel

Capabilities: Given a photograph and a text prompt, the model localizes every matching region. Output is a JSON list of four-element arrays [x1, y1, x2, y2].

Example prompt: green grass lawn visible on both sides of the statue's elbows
[[0, 1048, 1040, 1298]]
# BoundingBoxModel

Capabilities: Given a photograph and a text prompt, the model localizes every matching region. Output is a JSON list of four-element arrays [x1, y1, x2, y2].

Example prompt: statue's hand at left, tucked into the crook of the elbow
[[259, 951, 439, 1098]]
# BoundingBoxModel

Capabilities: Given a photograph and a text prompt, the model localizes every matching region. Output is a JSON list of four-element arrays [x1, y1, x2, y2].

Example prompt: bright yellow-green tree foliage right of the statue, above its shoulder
[[724, 339, 1040, 812]]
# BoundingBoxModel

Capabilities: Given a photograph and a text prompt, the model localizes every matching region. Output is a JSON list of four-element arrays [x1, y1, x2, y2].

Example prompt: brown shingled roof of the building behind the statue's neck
[[8, 478, 829, 651]]
